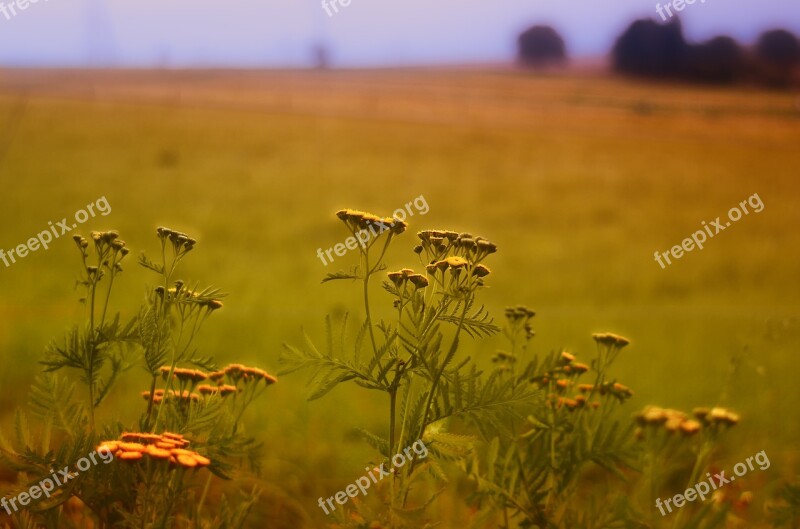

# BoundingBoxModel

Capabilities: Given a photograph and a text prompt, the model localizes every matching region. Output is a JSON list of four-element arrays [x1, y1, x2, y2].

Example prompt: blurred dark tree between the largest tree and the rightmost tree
[[685, 36, 745, 83]]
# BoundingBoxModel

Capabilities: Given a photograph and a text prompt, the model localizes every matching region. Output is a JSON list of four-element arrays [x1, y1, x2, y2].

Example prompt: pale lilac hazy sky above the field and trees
[[0, 0, 800, 66]]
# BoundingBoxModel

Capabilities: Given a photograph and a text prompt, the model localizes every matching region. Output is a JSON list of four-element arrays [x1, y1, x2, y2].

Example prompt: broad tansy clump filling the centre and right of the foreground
[[281, 206, 764, 529]]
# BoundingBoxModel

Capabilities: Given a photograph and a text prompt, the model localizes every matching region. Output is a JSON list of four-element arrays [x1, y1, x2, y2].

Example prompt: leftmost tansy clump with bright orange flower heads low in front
[[0, 227, 277, 529]]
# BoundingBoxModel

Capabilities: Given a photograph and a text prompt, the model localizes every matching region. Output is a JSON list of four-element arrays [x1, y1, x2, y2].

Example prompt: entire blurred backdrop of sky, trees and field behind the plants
[[0, 0, 800, 527]]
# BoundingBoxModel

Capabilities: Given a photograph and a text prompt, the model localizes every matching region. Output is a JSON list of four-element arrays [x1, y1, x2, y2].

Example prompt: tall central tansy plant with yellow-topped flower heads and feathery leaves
[[281, 210, 536, 528]]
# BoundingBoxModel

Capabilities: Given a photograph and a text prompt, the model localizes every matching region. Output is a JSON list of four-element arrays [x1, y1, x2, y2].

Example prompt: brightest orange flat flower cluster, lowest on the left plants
[[97, 432, 211, 468]]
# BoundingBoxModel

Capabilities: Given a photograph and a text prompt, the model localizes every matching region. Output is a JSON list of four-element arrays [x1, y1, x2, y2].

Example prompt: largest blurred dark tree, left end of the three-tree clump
[[612, 18, 688, 77]]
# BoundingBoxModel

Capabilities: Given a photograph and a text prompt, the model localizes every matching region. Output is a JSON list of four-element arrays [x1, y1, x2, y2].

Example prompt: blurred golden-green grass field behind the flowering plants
[[0, 69, 800, 527]]
